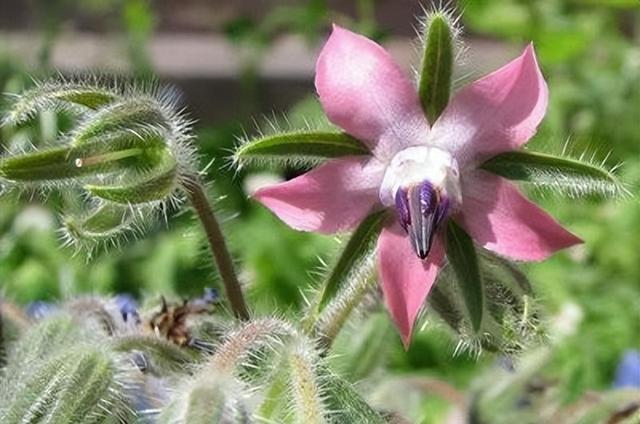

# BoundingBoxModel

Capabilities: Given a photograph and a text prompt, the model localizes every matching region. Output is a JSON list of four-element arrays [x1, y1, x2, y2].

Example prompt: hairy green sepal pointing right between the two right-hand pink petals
[[482, 150, 628, 197]]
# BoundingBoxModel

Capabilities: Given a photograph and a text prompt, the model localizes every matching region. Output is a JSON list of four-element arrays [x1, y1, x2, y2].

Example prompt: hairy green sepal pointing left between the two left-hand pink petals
[[234, 131, 370, 163]]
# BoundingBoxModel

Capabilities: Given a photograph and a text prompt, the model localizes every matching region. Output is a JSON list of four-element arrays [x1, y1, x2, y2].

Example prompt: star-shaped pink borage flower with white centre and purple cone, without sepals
[[246, 22, 581, 345]]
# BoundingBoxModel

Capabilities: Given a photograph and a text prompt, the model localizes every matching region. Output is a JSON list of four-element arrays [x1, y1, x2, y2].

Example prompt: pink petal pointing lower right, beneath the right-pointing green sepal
[[461, 170, 582, 261]]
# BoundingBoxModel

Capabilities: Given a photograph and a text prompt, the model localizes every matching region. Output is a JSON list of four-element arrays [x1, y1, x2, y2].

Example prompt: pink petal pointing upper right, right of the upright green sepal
[[431, 44, 548, 165]]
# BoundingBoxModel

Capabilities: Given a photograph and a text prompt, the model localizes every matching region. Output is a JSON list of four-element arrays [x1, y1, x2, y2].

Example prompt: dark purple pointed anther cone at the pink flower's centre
[[395, 181, 450, 259]]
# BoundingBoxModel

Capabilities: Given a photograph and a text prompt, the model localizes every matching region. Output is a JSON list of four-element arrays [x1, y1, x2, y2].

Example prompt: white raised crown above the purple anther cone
[[380, 146, 462, 209]]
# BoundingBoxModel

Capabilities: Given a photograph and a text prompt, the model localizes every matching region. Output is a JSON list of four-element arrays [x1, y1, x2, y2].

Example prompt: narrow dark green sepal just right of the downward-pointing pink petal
[[447, 220, 484, 333]]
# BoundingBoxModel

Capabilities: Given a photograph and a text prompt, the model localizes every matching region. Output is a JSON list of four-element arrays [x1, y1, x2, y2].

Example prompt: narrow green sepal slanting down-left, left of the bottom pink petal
[[318, 210, 387, 310]]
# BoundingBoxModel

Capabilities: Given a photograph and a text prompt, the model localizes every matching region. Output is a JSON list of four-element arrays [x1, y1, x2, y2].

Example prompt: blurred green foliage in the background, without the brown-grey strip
[[0, 0, 640, 423]]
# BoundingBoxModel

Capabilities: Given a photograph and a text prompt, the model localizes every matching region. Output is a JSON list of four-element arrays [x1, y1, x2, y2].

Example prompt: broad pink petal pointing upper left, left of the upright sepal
[[315, 25, 429, 159]]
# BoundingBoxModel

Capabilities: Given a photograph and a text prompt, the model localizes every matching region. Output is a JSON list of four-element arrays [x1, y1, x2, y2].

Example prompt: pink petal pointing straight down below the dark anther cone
[[378, 223, 444, 348]]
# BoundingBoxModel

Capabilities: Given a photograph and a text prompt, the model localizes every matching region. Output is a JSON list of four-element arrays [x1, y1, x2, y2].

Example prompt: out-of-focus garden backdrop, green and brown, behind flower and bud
[[0, 0, 640, 423]]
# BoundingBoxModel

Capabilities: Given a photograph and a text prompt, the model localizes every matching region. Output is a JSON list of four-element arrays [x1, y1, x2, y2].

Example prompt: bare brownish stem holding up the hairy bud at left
[[183, 175, 249, 320]]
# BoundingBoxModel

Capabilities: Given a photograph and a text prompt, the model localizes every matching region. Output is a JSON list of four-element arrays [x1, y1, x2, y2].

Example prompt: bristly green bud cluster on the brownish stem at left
[[0, 80, 197, 250]]
